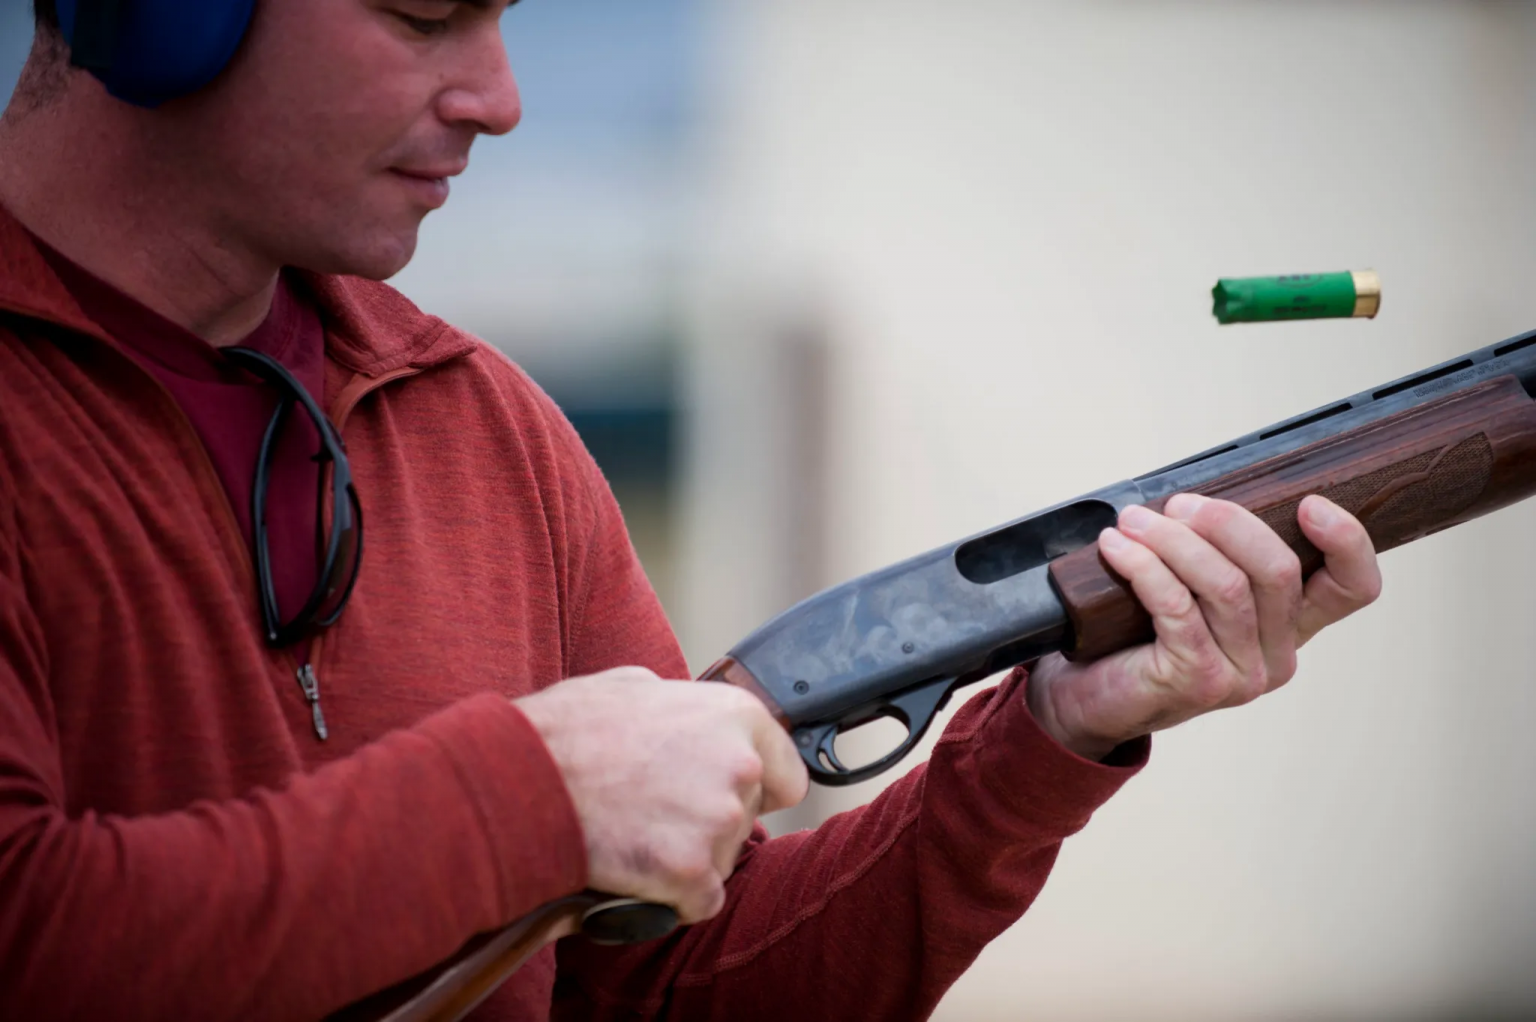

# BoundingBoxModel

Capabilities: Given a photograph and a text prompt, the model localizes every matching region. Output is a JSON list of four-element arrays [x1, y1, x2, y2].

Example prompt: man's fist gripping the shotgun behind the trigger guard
[[518, 667, 809, 922]]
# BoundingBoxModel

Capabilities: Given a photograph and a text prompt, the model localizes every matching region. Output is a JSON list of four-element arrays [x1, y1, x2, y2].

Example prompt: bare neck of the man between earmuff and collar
[[0, 76, 281, 347]]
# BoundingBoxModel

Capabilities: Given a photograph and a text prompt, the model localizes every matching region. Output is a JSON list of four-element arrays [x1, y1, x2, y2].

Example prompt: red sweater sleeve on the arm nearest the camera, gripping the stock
[[0, 519, 585, 1022]]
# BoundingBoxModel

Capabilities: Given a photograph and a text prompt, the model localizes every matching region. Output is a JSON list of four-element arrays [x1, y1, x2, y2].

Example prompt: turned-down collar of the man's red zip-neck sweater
[[0, 206, 475, 377]]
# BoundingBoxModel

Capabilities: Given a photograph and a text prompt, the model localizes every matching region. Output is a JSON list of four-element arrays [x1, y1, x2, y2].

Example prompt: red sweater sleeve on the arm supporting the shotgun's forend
[[554, 427, 1149, 1022]]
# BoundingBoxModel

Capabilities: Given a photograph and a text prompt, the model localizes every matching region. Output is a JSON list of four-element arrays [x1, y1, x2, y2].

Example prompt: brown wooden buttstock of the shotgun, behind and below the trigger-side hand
[[336, 656, 790, 1022]]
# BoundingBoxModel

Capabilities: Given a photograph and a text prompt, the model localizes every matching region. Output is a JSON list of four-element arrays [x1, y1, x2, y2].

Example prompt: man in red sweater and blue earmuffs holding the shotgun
[[0, 0, 1379, 1019]]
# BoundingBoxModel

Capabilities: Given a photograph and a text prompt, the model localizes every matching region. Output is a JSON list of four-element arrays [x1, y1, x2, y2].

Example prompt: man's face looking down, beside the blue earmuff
[[164, 0, 522, 278]]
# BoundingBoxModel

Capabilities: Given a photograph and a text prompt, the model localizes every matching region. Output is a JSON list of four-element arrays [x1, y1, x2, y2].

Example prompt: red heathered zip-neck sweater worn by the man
[[0, 211, 1146, 1022]]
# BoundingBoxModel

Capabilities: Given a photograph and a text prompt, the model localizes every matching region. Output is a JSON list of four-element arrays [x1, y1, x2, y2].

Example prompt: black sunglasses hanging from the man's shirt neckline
[[224, 347, 362, 647]]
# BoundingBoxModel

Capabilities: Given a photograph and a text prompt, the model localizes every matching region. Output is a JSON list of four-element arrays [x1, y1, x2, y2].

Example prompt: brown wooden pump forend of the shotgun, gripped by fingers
[[1051, 377, 1536, 661]]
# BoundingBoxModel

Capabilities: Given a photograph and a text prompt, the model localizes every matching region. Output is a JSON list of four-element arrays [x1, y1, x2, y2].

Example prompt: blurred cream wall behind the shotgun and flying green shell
[[680, 0, 1536, 1020]]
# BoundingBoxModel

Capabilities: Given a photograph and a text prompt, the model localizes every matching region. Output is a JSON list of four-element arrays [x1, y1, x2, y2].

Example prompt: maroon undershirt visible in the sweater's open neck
[[38, 241, 326, 664]]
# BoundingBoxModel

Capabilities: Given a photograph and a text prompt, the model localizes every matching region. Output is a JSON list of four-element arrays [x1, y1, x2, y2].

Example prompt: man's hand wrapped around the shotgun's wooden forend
[[1029, 493, 1381, 759]]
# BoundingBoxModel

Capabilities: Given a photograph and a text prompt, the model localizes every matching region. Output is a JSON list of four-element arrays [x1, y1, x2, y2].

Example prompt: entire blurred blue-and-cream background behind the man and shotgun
[[0, 0, 1536, 1022]]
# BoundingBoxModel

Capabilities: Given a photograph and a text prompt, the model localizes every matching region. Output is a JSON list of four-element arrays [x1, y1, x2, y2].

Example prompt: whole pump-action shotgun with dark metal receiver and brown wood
[[344, 330, 1536, 1022]]
